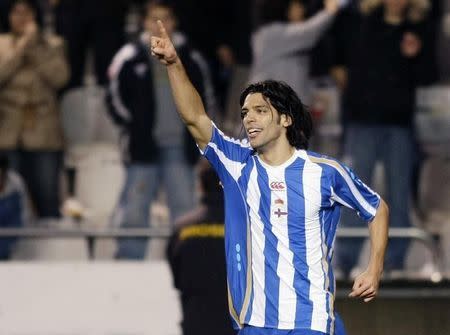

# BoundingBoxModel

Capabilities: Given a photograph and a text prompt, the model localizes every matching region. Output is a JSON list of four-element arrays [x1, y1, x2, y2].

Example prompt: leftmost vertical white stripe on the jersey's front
[[247, 165, 266, 327]]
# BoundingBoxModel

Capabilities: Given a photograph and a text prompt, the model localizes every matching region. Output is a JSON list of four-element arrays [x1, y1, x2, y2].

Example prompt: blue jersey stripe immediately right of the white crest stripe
[[285, 159, 313, 328]]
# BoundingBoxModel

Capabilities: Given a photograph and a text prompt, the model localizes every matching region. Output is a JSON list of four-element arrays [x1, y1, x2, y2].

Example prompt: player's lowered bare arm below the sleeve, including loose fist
[[349, 199, 389, 302]]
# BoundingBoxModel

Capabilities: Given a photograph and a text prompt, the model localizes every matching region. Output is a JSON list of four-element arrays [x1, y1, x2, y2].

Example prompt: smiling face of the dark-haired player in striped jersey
[[241, 93, 290, 151]]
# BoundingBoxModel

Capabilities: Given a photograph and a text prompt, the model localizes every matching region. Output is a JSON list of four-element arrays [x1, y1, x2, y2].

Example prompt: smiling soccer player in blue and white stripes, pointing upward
[[150, 22, 388, 335]]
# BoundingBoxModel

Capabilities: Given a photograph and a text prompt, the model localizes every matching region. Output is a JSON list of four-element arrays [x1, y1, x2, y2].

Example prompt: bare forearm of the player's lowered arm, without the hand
[[368, 199, 389, 275]]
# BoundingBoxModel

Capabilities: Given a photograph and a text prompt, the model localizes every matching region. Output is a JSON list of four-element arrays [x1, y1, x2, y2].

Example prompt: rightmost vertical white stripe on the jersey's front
[[302, 160, 328, 333]]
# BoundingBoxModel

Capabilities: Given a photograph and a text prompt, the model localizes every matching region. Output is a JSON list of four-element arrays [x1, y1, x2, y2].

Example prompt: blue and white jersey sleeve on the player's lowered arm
[[331, 163, 380, 222]]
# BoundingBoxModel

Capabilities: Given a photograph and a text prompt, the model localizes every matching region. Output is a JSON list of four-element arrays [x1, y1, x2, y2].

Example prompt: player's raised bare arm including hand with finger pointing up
[[150, 21, 212, 150]]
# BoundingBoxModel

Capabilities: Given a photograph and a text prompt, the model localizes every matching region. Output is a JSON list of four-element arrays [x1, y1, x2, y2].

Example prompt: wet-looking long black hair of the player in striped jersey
[[239, 80, 313, 149]]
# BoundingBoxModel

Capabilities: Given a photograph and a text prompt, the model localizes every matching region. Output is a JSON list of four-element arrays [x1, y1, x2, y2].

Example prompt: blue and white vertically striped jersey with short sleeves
[[203, 126, 380, 334]]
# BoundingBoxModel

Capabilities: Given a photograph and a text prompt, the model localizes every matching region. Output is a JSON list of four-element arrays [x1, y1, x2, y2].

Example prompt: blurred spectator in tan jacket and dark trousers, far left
[[0, 0, 69, 217]]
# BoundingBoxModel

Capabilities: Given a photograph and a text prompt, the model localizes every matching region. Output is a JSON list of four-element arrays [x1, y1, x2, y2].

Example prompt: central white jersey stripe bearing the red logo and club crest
[[266, 168, 300, 329]]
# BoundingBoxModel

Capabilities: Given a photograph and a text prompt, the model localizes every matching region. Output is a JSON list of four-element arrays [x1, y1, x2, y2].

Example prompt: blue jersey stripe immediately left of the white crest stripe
[[256, 161, 280, 327]]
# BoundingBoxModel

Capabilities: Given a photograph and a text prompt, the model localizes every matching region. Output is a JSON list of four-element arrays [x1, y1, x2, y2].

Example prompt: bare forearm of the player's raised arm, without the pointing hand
[[167, 58, 206, 126]]
